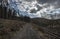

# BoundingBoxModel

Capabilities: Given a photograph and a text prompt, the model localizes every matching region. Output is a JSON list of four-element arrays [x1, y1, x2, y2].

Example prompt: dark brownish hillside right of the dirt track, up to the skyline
[[32, 18, 60, 39]]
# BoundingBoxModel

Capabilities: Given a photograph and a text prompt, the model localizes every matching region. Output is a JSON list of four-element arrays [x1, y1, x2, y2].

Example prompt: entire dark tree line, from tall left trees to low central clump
[[0, 4, 30, 22]]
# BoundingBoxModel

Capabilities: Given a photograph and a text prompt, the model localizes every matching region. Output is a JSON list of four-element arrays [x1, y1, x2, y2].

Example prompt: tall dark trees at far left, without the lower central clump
[[0, 4, 16, 18]]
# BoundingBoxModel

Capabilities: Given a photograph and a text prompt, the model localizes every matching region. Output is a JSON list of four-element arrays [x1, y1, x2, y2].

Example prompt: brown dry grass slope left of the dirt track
[[0, 19, 25, 39]]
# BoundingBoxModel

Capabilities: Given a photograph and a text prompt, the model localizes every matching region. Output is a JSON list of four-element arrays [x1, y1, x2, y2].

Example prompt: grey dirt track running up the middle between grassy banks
[[13, 23, 41, 39]]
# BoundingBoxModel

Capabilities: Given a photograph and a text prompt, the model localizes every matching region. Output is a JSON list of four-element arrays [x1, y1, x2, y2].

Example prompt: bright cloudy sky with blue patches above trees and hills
[[8, 0, 60, 19]]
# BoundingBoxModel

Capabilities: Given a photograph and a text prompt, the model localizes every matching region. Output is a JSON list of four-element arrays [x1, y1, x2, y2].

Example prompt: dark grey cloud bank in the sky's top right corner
[[37, 0, 60, 8]]
